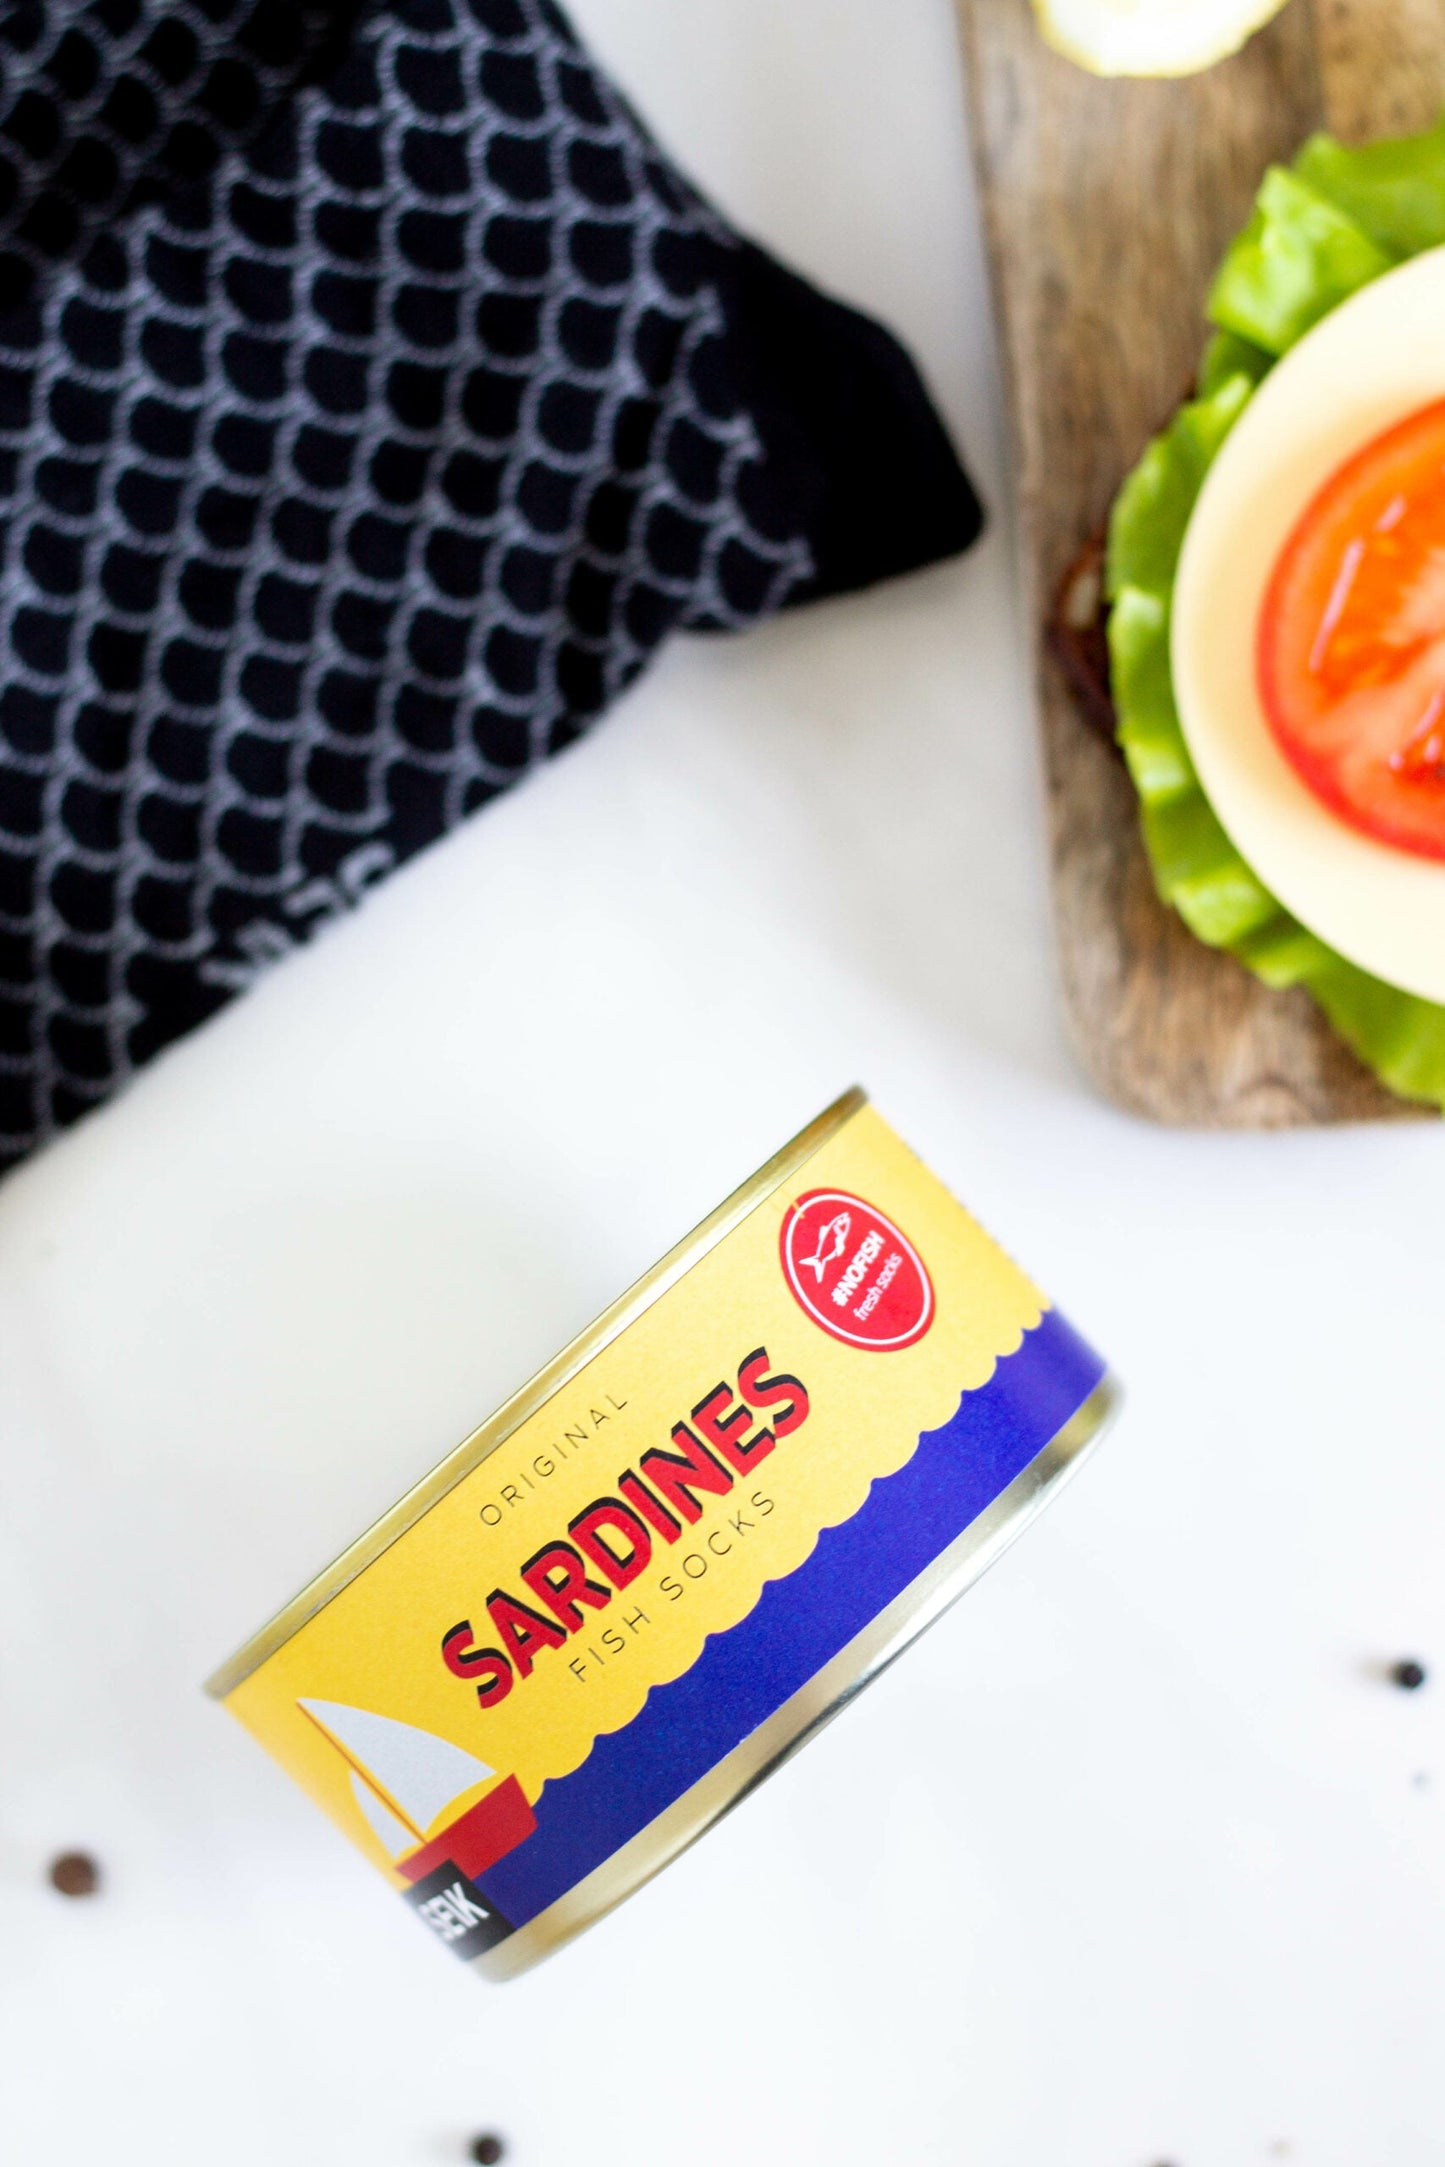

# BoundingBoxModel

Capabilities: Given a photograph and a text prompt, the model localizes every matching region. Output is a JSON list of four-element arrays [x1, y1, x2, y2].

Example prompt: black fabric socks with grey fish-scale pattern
[[0, 0, 979, 1166]]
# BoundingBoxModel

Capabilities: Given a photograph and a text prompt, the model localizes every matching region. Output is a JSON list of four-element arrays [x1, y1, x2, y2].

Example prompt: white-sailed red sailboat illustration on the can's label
[[297, 1701, 537, 1883]]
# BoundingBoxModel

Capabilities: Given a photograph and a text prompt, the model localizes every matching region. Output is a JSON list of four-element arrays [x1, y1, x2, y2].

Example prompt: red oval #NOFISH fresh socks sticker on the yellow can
[[780, 1190, 934, 1350]]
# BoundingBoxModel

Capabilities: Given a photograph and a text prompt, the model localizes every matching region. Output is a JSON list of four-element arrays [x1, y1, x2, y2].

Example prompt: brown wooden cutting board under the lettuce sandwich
[[960, 0, 1445, 1129]]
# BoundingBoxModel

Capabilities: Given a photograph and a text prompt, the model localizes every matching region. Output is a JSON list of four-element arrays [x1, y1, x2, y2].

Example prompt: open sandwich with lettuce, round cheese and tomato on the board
[[1055, 119, 1445, 1110]]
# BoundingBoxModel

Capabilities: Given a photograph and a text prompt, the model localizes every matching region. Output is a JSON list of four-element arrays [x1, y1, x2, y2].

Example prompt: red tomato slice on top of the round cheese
[[1257, 399, 1445, 858]]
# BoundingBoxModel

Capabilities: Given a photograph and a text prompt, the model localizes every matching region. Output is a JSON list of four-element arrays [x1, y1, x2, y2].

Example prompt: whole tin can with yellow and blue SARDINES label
[[208, 1090, 1116, 1978]]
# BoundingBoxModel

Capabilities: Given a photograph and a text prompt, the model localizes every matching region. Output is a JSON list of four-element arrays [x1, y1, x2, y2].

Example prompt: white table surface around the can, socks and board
[[0, 0, 1445, 2167]]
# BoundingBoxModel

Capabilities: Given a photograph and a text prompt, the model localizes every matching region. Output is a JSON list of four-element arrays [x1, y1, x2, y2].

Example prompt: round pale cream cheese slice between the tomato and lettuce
[[1170, 249, 1445, 1003]]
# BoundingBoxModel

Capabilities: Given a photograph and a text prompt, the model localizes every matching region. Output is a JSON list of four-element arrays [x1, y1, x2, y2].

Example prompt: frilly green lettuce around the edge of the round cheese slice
[[1107, 117, 1445, 1107]]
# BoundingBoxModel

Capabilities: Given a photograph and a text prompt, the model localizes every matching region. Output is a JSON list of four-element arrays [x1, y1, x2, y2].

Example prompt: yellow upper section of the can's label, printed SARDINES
[[217, 1107, 1083, 1931]]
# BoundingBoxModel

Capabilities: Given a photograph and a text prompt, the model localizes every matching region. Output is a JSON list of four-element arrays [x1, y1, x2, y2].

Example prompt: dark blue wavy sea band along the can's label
[[481, 1309, 1105, 1926]]
